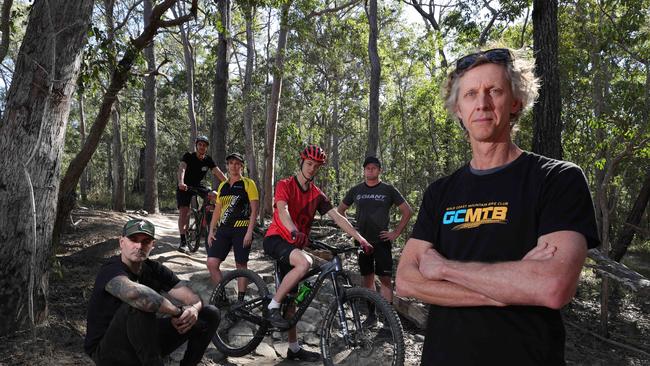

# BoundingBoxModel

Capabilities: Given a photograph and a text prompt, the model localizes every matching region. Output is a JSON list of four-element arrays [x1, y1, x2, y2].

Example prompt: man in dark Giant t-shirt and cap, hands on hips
[[338, 156, 413, 323]]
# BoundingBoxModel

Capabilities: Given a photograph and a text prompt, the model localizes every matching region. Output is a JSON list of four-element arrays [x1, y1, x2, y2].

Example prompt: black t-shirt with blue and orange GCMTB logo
[[411, 152, 599, 365]]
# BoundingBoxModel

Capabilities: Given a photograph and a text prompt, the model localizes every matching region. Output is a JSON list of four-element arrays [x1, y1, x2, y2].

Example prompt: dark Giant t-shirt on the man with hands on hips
[[343, 182, 404, 243]]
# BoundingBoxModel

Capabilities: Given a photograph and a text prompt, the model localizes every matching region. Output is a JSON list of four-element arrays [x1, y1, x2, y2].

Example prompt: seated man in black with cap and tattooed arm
[[84, 219, 219, 366]]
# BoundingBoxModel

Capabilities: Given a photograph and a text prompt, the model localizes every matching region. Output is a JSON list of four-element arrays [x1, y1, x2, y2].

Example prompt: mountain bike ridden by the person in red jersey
[[210, 242, 404, 366]]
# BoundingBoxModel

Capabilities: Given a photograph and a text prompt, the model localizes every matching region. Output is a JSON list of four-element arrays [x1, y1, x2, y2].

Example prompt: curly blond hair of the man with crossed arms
[[443, 48, 539, 128]]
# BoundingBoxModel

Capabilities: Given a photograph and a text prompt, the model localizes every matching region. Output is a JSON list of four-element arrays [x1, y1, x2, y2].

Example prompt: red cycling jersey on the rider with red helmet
[[266, 176, 333, 244]]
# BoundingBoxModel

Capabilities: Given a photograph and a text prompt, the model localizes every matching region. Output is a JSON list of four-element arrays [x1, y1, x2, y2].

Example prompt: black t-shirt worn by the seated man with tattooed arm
[[84, 256, 180, 355]]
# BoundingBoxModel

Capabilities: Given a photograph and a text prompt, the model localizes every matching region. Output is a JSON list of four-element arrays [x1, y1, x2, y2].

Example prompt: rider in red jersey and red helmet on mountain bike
[[264, 145, 372, 362]]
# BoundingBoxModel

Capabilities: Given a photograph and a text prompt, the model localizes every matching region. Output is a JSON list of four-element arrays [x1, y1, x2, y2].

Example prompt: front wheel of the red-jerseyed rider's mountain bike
[[320, 288, 404, 366]]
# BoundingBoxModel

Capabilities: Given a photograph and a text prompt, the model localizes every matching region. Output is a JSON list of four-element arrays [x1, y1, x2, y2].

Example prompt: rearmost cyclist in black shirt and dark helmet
[[176, 136, 226, 253]]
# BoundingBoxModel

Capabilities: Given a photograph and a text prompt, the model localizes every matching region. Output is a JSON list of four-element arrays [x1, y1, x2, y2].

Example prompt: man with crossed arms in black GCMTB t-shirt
[[396, 49, 599, 366]]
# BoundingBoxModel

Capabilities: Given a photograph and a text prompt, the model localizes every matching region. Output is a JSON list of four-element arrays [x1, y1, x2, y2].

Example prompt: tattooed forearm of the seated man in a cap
[[105, 276, 182, 316]]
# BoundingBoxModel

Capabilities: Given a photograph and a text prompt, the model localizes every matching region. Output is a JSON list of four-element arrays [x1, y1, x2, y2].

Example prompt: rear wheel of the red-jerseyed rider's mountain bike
[[210, 269, 269, 357]]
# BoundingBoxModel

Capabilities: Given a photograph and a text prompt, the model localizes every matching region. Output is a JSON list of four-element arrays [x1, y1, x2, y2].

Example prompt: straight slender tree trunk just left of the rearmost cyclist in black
[[142, 0, 159, 213]]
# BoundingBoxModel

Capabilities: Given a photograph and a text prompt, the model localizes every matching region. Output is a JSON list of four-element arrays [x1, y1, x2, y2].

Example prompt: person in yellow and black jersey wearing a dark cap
[[206, 153, 260, 286]]
